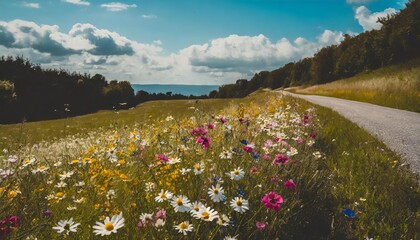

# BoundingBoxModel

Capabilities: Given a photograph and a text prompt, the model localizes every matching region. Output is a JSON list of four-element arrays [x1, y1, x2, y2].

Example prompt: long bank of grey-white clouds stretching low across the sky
[[0, 19, 343, 84]]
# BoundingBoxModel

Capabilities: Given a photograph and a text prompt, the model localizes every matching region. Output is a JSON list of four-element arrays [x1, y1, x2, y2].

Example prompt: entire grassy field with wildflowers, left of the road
[[0, 91, 420, 239]]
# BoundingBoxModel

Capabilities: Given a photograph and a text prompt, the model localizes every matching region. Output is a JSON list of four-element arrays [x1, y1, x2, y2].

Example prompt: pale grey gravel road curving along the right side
[[282, 91, 420, 173]]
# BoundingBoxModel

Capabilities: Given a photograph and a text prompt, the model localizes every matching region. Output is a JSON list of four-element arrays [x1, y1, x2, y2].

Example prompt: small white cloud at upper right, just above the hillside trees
[[354, 6, 397, 31]]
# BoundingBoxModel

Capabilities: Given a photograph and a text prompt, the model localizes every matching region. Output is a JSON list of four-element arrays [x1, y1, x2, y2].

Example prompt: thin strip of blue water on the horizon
[[131, 84, 219, 96]]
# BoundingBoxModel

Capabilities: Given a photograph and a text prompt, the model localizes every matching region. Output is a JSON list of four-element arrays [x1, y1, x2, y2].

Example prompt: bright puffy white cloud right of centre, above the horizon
[[181, 30, 343, 74]]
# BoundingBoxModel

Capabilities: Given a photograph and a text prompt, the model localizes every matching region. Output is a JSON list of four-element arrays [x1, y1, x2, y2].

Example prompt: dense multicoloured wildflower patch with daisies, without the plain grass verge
[[0, 92, 420, 239]]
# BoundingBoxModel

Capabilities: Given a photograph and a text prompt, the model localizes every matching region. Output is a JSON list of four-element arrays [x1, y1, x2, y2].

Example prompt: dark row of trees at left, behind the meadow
[[0, 56, 207, 124]]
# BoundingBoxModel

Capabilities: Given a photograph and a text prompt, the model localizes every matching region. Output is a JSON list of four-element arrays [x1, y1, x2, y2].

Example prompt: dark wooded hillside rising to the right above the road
[[210, 0, 420, 98]]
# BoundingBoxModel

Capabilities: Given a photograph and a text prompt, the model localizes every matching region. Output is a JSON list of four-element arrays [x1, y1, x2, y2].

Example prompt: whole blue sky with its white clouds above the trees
[[0, 0, 404, 84]]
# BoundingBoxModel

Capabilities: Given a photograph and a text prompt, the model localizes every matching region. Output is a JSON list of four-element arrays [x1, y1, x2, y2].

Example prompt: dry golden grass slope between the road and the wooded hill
[[292, 59, 420, 112]]
